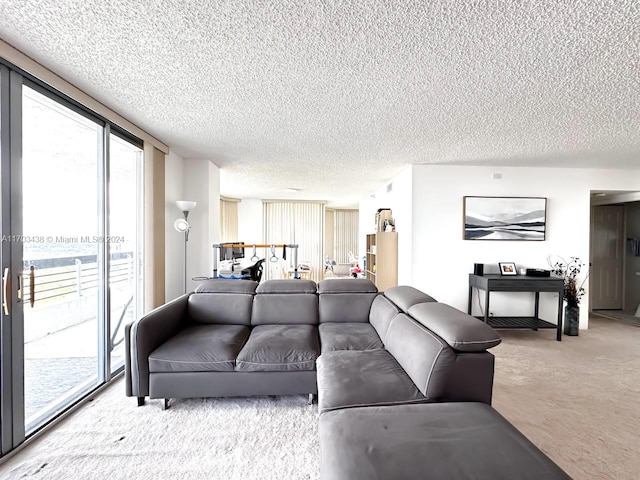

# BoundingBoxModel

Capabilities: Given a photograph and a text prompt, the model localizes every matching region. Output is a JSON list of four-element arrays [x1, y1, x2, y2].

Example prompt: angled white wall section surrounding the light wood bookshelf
[[358, 167, 414, 285]]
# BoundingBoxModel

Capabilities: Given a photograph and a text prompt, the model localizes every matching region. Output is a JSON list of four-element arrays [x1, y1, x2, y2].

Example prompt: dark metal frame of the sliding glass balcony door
[[0, 58, 143, 456]]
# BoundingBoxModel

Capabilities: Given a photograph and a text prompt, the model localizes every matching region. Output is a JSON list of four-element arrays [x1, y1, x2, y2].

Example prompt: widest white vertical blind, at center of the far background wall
[[264, 201, 325, 282]]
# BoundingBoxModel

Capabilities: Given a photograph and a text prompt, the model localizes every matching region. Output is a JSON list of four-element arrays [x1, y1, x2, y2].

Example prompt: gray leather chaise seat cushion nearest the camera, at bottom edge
[[319, 402, 570, 480]]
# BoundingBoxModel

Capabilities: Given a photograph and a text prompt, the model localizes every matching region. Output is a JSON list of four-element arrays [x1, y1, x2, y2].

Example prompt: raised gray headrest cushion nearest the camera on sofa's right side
[[409, 303, 502, 352]]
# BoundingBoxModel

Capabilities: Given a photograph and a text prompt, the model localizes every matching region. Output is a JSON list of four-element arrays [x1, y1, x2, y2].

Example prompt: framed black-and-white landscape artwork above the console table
[[463, 197, 547, 241]]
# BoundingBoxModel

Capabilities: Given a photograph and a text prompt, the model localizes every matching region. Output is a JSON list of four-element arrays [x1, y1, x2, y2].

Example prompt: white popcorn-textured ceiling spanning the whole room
[[0, 0, 640, 205]]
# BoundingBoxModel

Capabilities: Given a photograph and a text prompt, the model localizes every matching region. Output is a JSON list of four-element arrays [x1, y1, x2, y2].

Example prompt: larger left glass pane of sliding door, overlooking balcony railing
[[21, 86, 103, 433]]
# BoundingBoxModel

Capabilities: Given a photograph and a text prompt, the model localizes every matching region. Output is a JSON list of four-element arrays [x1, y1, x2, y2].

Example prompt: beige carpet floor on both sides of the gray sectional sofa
[[0, 317, 640, 480]]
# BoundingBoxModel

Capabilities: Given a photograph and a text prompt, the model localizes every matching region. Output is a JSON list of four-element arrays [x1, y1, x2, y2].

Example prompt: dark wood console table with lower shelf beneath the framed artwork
[[467, 273, 564, 341]]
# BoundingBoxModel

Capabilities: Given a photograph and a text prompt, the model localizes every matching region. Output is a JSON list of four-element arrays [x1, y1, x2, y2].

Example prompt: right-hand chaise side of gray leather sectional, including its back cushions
[[317, 287, 570, 480]]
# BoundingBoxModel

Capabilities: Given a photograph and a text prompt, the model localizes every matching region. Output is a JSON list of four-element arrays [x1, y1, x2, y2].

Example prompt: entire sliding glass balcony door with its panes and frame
[[0, 64, 142, 454]]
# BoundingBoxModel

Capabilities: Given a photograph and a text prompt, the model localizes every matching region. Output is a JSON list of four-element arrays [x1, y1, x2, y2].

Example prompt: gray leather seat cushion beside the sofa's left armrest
[[149, 325, 250, 373]]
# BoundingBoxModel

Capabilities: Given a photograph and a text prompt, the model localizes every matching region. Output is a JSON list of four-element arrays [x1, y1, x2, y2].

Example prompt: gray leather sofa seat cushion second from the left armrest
[[236, 325, 320, 372]]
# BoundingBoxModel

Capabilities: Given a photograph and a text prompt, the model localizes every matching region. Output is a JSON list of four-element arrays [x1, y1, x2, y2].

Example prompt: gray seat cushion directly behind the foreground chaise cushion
[[317, 350, 428, 413]]
